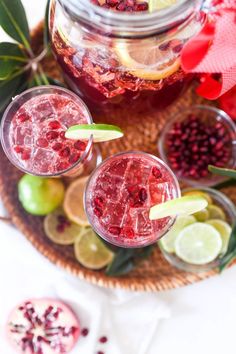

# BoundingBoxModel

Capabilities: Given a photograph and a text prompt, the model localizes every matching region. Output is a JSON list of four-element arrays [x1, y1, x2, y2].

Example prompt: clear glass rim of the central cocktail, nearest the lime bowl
[[83, 150, 181, 248]]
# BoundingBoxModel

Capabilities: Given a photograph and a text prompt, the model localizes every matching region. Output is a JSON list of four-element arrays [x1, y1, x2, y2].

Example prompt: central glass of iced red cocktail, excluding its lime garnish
[[85, 152, 180, 247]]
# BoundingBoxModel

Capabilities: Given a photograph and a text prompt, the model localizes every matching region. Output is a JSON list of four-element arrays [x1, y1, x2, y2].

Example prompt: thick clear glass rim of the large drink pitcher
[[58, 0, 204, 36]]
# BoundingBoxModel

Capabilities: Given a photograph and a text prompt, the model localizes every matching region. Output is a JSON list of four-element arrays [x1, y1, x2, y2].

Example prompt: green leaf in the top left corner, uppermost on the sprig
[[0, 0, 30, 49]]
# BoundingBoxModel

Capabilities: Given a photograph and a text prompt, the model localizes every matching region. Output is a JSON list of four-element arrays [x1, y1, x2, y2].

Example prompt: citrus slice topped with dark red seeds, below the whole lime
[[44, 209, 84, 245]]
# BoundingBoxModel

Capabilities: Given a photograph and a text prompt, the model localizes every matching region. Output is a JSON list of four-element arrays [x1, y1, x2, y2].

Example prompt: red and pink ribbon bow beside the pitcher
[[181, 0, 236, 99]]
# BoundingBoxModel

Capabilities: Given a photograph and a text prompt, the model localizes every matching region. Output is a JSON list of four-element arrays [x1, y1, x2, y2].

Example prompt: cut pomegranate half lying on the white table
[[7, 299, 80, 354]]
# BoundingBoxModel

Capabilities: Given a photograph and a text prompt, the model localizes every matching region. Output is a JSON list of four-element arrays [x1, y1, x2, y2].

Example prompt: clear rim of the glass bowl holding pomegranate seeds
[[157, 105, 236, 187]]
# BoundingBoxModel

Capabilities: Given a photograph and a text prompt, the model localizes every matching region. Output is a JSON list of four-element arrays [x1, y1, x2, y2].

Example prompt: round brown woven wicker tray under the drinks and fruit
[[0, 24, 236, 291]]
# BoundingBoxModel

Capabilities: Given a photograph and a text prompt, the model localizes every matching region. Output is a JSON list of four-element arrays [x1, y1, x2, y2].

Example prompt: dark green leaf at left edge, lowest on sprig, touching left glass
[[0, 76, 22, 112]]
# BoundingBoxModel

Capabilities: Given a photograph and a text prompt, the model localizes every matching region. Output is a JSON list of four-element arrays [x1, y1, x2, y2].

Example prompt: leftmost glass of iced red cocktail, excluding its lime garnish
[[1, 86, 101, 176]]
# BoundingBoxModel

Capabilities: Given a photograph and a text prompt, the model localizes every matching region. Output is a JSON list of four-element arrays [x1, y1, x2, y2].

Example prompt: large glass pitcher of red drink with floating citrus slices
[[50, 0, 205, 112]]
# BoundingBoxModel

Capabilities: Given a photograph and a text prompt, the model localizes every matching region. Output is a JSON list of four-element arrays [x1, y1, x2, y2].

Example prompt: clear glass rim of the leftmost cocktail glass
[[0, 85, 93, 177]]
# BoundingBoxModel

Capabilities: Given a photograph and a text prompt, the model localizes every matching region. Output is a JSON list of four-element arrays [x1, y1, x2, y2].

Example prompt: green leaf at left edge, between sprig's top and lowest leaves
[[0, 42, 27, 80]]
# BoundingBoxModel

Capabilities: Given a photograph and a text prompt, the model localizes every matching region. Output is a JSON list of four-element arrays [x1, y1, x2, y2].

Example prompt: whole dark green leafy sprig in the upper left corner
[[0, 0, 60, 113]]
